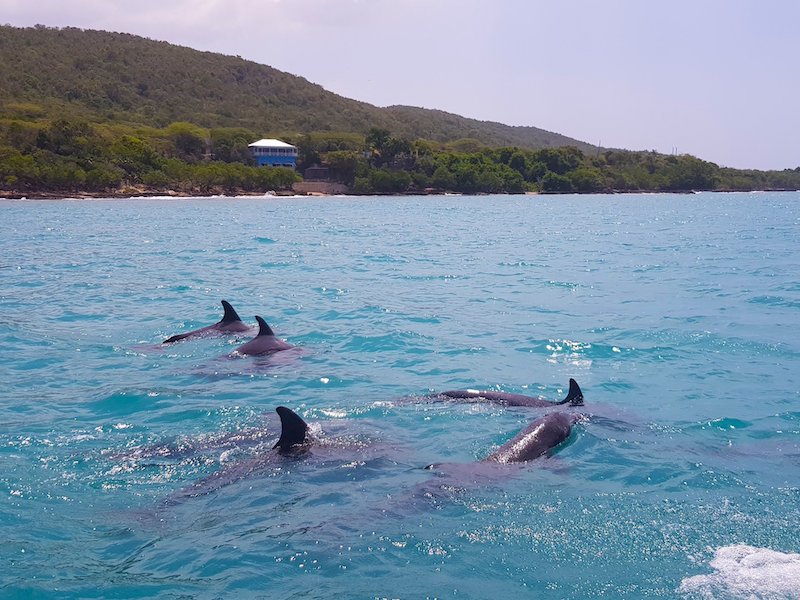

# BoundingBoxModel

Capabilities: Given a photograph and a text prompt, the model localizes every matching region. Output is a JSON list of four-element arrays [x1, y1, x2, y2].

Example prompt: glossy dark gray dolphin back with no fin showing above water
[[483, 412, 581, 464]]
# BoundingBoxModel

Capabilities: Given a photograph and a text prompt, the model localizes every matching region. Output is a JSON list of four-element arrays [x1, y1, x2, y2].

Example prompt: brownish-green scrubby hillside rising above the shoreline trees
[[0, 26, 593, 150]]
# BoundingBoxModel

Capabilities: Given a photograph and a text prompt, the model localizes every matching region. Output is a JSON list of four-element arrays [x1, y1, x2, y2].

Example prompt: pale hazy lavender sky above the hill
[[0, 0, 800, 169]]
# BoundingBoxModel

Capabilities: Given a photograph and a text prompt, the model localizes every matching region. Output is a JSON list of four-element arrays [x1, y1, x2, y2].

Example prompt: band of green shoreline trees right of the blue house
[[298, 129, 800, 193]]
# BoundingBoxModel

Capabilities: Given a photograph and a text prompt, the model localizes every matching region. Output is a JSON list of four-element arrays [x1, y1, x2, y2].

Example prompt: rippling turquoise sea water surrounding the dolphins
[[0, 193, 800, 599]]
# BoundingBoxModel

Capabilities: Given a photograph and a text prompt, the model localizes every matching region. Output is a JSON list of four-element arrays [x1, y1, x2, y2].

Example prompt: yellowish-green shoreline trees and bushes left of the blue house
[[0, 119, 300, 194]]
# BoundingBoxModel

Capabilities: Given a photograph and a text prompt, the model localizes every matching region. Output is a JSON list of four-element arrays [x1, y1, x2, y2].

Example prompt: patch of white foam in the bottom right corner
[[678, 544, 800, 600]]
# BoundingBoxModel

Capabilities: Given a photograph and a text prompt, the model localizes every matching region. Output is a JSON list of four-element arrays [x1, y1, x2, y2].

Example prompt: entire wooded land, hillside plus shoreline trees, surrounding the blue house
[[0, 26, 800, 194]]
